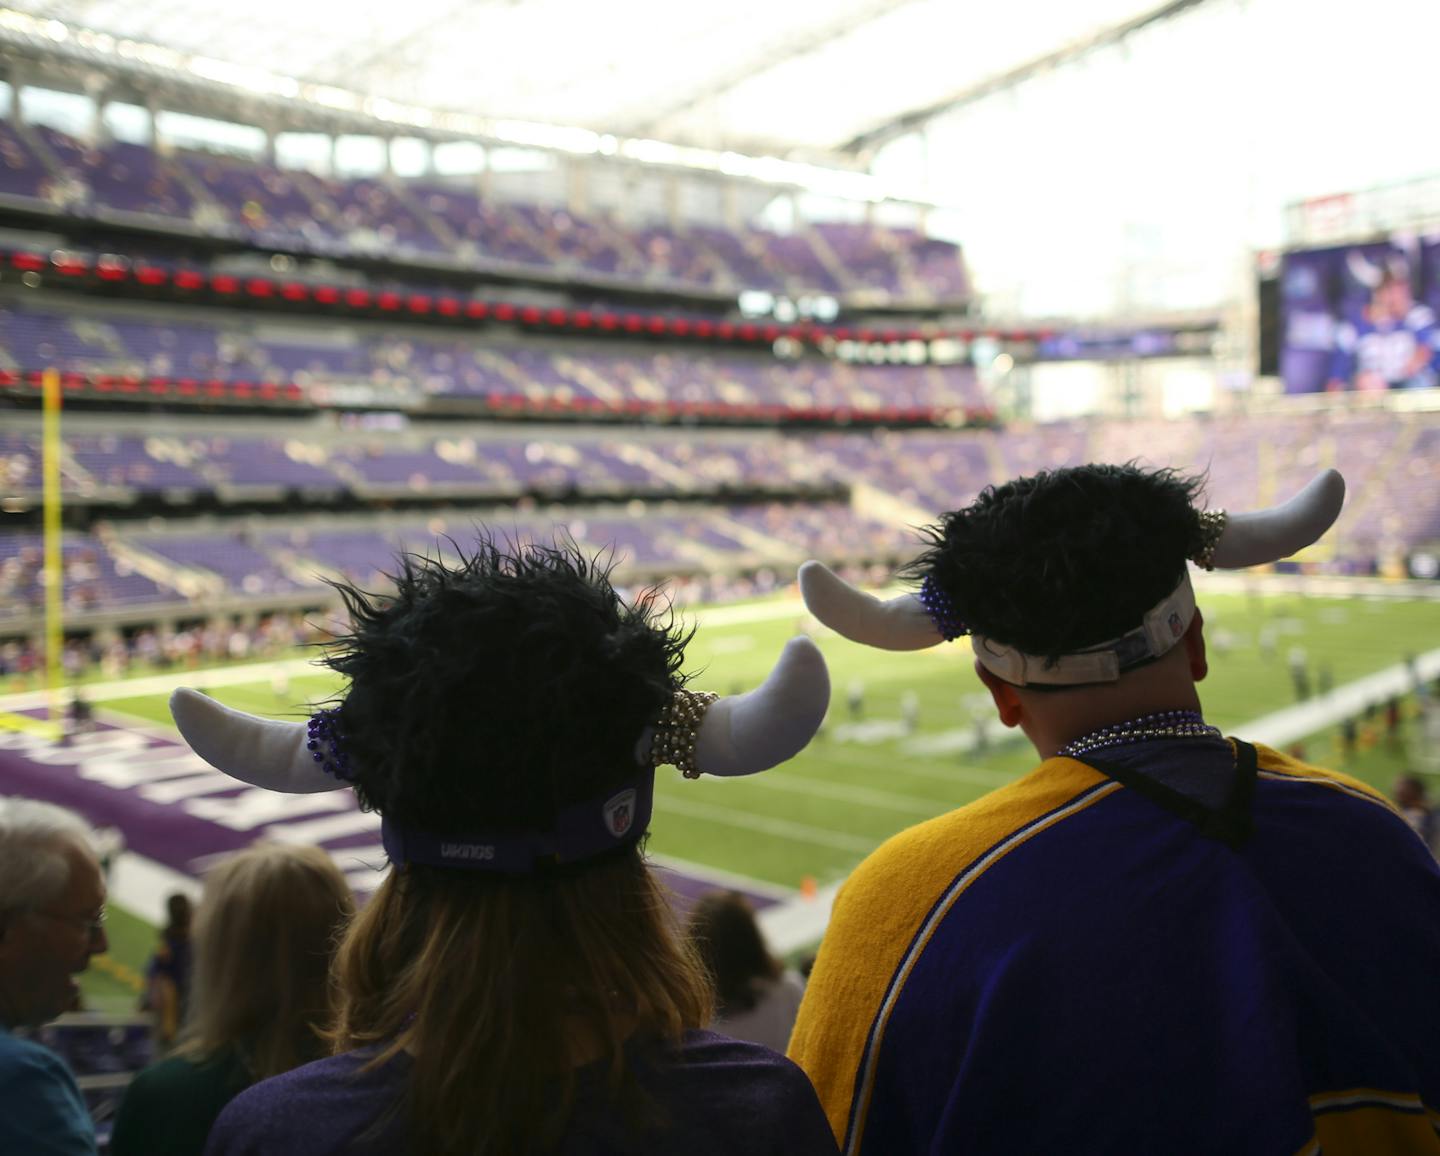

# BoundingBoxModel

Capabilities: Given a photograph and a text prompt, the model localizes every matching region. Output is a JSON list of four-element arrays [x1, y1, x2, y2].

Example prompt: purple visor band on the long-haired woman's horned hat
[[315, 710, 655, 875]]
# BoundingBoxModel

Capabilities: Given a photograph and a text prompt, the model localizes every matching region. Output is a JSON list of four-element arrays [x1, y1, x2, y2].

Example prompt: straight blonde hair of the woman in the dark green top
[[179, 844, 354, 1080]]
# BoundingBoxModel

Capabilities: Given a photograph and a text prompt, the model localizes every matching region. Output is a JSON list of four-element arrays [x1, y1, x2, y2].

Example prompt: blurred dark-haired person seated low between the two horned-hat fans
[[688, 891, 805, 1051]]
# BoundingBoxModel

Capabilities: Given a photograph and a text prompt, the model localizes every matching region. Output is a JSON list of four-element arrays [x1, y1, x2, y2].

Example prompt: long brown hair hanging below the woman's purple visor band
[[333, 846, 710, 1156]]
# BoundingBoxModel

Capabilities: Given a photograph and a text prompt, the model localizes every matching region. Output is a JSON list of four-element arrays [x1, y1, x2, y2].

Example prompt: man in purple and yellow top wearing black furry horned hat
[[791, 465, 1440, 1156]]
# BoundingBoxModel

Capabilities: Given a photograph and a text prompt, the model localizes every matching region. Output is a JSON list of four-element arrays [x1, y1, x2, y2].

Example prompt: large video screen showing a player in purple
[[1280, 236, 1440, 393]]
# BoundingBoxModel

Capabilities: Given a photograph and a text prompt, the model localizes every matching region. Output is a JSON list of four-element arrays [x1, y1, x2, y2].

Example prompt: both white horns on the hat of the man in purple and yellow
[[799, 469, 1345, 651]]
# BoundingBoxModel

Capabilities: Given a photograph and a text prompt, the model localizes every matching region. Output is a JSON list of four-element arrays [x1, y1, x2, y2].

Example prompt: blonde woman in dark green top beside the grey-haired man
[[111, 844, 354, 1156]]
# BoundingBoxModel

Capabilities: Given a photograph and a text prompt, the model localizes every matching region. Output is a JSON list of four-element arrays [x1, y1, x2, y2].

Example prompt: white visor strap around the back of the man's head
[[971, 570, 1195, 687]]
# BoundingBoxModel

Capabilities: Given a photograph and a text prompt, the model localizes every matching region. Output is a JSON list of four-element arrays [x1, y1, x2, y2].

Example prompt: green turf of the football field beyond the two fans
[[64, 592, 1440, 1003]]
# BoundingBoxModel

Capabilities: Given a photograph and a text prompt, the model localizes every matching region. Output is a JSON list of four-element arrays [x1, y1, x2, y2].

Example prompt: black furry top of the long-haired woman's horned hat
[[325, 533, 690, 832]]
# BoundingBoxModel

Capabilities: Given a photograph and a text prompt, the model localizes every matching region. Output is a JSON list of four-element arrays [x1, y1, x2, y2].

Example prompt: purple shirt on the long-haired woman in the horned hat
[[204, 1032, 835, 1156]]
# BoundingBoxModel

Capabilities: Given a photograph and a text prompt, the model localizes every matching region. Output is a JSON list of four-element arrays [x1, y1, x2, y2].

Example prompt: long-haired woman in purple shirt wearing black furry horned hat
[[171, 541, 834, 1156]]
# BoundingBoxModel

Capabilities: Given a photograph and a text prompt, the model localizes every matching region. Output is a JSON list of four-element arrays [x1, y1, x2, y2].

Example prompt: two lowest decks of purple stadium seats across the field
[[0, 408, 1440, 618]]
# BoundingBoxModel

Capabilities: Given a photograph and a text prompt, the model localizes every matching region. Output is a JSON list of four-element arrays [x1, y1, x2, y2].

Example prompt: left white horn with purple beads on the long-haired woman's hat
[[170, 687, 348, 795]]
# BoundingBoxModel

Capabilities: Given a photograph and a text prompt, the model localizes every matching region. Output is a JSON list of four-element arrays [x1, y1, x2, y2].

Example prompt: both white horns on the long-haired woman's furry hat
[[170, 636, 829, 795]]
